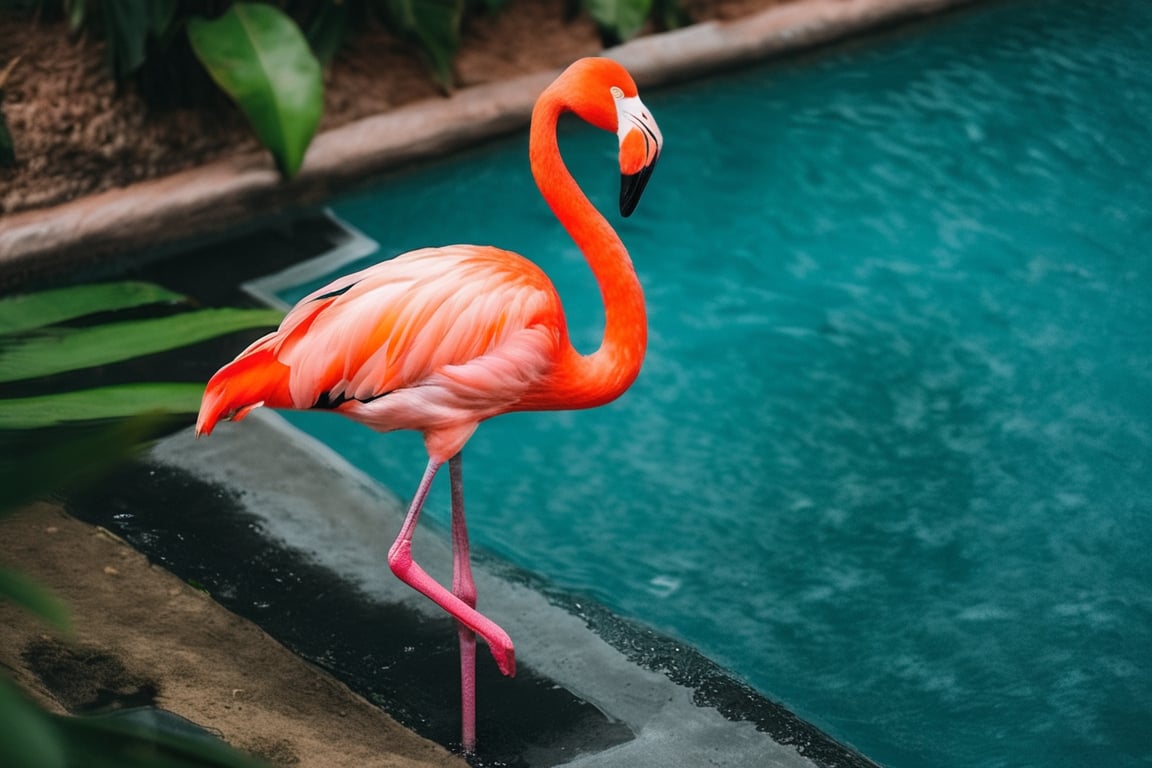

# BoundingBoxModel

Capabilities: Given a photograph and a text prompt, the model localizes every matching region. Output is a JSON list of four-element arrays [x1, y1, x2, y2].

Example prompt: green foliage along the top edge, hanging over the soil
[[0, 0, 688, 177]]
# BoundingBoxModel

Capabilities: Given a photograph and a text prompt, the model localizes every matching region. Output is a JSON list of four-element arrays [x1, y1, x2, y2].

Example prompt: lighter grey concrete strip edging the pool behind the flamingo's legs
[[141, 409, 874, 768]]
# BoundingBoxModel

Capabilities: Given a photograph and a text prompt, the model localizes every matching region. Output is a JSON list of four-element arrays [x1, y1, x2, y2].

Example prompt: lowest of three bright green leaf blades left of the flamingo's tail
[[0, 383, 204, 429]]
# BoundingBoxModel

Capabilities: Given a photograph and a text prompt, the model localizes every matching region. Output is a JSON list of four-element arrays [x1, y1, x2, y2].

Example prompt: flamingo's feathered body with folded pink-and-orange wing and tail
[[197, 245, 566, 439]]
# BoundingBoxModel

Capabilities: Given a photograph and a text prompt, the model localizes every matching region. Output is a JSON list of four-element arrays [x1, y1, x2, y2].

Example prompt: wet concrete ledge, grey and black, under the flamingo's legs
[[68, 409, 876, 768]]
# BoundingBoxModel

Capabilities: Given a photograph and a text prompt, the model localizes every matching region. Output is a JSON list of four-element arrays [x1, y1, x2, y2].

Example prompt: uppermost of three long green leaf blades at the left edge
[[0, 282, 184, 335]]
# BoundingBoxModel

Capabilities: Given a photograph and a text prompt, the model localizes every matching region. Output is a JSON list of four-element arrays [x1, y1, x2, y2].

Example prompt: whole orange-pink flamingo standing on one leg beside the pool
[[196, 58, 664, 753]]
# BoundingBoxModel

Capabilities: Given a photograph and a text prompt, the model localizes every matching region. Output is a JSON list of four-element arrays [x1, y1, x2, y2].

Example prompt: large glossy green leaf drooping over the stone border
[[188, 2, 324, 176]]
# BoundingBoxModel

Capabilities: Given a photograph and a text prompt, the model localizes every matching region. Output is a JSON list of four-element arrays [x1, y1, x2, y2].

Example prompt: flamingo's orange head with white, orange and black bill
[[556, 58, 664, 216]]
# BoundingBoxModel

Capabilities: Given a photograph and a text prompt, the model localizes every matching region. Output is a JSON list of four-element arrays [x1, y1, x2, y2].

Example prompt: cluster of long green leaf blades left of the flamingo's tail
[[0, 281, 281, 511]]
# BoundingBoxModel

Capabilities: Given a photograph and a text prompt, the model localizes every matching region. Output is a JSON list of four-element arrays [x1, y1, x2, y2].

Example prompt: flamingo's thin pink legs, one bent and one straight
[[388, 456, 516, 732]]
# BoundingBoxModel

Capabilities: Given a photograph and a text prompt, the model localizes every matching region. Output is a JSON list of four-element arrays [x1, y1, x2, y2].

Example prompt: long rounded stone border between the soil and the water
[[0, 0, 972, 289]]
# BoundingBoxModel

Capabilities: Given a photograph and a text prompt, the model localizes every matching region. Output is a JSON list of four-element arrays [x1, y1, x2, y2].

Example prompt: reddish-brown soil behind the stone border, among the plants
[[0, 0, 787, 214]]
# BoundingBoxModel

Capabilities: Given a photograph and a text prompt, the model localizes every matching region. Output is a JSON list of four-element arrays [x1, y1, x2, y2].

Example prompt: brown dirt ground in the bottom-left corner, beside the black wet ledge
[[0, 504, 465, 768]]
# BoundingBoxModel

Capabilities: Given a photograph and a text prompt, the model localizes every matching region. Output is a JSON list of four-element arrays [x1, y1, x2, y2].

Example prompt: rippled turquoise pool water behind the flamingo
[[276, 0, 1152, 767]]
